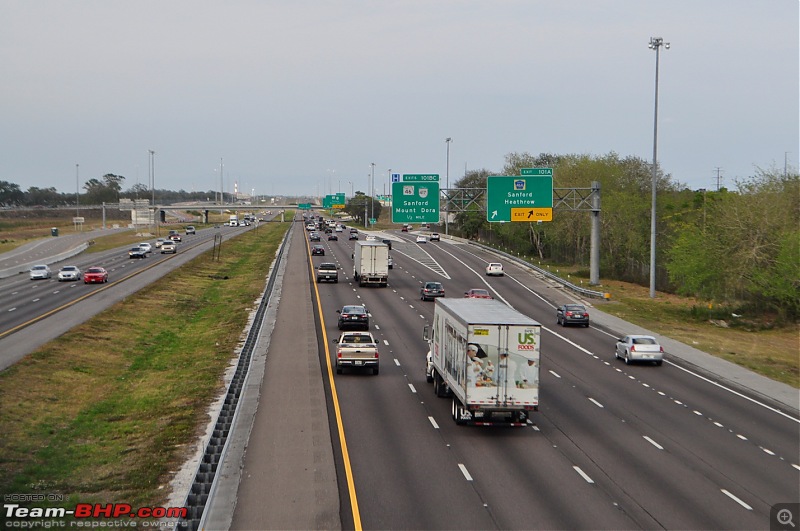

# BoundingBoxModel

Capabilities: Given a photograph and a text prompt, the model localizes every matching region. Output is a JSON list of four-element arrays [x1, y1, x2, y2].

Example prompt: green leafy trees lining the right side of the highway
[[450, 153, 800, 322]]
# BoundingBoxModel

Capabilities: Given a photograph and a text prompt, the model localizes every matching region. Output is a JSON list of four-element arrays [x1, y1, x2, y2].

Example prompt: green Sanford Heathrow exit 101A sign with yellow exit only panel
[[486, 174, 553, 223]]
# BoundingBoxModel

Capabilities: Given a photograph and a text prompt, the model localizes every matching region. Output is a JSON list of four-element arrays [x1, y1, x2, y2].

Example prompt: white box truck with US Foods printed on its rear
[[423, 298, 542, 426]]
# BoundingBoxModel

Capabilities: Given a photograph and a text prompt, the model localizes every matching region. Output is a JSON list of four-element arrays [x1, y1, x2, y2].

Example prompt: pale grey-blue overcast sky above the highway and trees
[[0, 0, 800, 199]]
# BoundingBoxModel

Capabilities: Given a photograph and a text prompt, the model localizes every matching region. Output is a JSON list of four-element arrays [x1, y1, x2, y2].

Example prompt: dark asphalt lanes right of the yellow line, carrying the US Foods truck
[[227, 222, 800, 529]]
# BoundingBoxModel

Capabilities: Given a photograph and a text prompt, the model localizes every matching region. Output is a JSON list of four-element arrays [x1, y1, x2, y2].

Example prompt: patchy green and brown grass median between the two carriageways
[[0, 223, 289, 507]]
